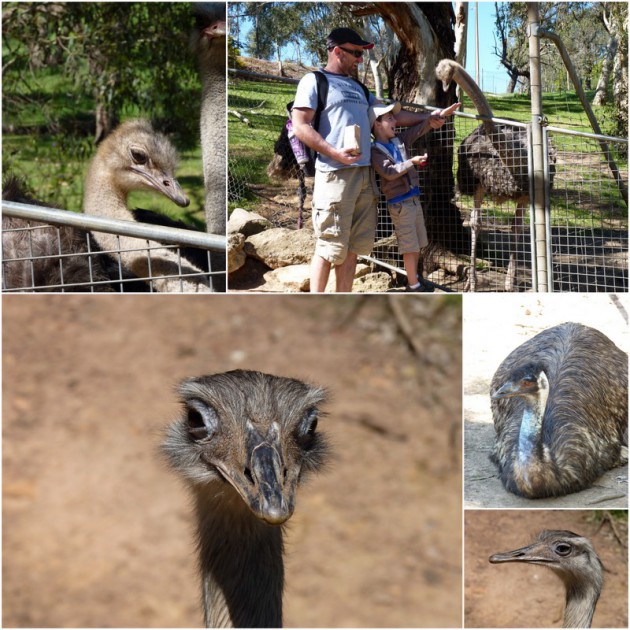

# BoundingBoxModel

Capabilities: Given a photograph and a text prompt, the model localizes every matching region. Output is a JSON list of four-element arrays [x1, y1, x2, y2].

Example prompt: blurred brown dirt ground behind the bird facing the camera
[[2, 295, 462, 627]]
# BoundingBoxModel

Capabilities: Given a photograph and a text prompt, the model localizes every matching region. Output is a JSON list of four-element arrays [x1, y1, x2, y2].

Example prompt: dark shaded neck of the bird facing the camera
[[195, 481, 284, 628]]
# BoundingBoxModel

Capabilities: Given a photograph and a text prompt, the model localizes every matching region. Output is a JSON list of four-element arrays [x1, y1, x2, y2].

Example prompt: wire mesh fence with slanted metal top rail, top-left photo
[[2, 201, 226, 293]]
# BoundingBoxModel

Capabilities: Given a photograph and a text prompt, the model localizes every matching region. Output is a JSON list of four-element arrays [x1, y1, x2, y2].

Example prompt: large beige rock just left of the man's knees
[[245, 228, 315, 269]]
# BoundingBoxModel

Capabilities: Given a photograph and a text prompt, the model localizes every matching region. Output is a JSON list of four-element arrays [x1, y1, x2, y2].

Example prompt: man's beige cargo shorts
[[313, 166, 377, 265]]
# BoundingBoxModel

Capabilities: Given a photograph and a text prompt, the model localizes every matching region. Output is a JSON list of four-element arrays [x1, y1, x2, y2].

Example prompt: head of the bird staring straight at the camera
[[163, 370, 327, 525]]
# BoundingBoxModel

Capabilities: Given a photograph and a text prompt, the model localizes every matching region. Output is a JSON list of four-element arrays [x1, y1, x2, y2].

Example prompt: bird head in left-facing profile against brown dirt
[[489, 530, 603, 593]]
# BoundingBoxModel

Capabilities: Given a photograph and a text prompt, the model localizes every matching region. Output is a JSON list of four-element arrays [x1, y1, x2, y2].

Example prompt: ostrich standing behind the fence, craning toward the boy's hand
[[435, 59, 556, 291]]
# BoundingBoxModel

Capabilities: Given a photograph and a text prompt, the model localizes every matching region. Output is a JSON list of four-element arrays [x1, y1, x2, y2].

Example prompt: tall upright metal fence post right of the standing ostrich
[[527, 2, 549, 292]]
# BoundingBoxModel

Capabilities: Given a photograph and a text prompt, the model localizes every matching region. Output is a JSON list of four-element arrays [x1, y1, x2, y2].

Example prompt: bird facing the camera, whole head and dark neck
[[162, 370, 328, 628]]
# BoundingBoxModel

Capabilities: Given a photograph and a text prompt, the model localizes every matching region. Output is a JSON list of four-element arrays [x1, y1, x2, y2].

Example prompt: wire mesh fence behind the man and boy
[[228, 71, 628, 291]]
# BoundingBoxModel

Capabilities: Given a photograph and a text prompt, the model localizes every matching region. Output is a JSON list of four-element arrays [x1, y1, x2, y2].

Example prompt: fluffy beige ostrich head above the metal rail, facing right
[[90, 120, 189, 207]]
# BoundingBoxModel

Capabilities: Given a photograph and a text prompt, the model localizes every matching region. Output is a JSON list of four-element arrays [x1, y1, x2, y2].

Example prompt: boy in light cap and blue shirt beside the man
[[369, 102, 459, 293]]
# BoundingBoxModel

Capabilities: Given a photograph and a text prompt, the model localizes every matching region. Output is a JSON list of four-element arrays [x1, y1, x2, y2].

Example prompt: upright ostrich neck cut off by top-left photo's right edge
[[198, 2, 227, 237]]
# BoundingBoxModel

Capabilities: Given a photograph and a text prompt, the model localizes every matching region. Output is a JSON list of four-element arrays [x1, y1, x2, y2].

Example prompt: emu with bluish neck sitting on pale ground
[[490, 323, 628, 499]]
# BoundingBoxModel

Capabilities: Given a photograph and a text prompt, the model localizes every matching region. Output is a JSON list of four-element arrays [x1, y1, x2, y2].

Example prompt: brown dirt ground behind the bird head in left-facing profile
[[464, 510, 628, 628]]
